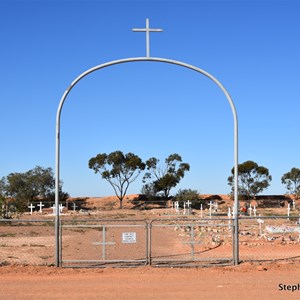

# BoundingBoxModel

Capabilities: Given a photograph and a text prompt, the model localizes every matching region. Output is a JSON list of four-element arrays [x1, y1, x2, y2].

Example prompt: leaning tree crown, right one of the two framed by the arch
[[142, 153, 190, 198]]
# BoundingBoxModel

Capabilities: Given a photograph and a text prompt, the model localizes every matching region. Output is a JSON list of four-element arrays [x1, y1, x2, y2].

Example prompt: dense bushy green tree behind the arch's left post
[[5, 166, 69, 212]]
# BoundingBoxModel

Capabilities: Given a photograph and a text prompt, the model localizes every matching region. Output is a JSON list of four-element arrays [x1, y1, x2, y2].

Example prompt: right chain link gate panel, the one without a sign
[[149, 219, 234, 267]]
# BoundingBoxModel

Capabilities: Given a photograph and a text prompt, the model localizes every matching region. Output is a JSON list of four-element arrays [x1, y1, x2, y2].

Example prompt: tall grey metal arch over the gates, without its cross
[[55, 56, 239, 267]]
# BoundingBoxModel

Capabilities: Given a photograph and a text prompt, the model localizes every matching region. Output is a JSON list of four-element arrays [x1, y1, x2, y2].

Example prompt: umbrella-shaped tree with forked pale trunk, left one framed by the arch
[[89, 151, 145, 208]]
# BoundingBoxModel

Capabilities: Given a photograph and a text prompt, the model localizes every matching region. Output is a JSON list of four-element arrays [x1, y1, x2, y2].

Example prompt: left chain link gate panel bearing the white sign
[[60, 220, 148, 267]]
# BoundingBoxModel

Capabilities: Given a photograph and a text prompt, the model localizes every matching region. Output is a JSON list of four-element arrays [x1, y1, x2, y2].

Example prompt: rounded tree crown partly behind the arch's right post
[[228, 160, 272, 199]]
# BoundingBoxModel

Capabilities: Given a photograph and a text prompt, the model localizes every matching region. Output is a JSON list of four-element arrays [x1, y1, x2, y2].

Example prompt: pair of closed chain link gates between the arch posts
[[60, 219, 234, 267]]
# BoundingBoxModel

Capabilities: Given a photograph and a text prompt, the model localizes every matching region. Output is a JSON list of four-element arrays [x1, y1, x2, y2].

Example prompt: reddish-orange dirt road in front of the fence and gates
[[0, 263, 300, 299]]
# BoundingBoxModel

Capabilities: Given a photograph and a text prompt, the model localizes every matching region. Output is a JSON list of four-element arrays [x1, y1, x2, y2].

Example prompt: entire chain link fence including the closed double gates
[[0, 215, 300, 267]]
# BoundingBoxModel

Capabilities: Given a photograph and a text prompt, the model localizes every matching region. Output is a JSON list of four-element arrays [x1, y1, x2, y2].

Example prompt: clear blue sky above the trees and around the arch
[[0, 0, 300, 196]]
